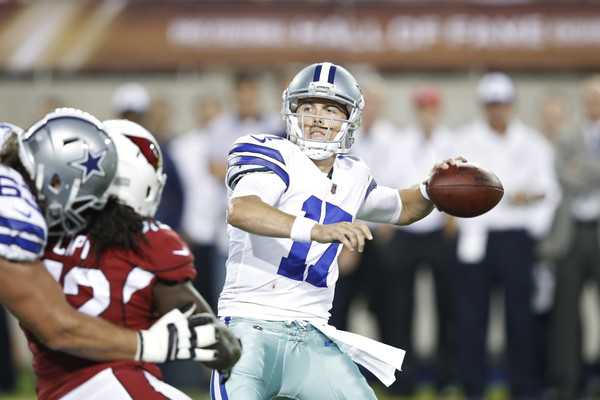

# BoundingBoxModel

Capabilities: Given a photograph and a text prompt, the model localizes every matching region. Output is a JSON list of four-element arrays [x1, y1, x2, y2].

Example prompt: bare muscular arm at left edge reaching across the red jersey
[[0, 258, 138, 361]]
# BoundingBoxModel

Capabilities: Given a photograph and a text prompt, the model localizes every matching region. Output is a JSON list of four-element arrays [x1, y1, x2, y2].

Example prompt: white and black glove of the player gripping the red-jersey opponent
[[135, 307, 219, 363]]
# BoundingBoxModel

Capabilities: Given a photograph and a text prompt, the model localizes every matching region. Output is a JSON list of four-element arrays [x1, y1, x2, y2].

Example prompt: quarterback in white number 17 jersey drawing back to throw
[[211, 62, 463, 400]]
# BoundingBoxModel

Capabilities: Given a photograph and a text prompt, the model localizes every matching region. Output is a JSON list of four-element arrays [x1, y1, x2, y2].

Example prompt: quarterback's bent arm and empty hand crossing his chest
[[227, 173, 373, 252]]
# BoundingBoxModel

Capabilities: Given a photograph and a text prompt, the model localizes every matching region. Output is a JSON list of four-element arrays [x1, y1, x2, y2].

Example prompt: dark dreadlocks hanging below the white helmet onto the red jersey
[[87, 196, 148, 256]]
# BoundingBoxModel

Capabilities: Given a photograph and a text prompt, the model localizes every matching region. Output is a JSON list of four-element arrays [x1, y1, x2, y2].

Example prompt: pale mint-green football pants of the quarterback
[[211, 317, 377, 400]]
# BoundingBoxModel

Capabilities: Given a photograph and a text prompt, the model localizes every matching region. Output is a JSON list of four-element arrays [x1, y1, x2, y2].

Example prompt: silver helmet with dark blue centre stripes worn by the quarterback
[[282, 62, 364, 160]]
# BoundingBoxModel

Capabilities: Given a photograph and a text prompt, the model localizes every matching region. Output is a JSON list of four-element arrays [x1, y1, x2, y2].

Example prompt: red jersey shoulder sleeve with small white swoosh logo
[[140, 223, 196, 282]]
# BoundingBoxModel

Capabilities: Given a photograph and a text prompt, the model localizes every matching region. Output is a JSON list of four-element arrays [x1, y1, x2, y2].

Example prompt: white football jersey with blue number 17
[[219, 135, 376, 323]]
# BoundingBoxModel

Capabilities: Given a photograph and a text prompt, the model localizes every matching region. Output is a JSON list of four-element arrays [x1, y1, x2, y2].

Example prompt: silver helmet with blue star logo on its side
[[18, 108, 118, 235]]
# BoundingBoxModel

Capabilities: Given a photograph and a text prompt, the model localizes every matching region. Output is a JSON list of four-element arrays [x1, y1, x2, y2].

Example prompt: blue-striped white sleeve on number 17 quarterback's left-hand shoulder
[[226, 135, 290, 190]]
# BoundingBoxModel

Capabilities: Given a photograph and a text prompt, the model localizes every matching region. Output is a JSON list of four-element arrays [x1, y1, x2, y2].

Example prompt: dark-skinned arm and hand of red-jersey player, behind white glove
[[152, 280, 242, 375]]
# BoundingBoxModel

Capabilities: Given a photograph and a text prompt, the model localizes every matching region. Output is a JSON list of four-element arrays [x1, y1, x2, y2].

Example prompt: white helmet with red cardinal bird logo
[[103, 119, 167, 217]]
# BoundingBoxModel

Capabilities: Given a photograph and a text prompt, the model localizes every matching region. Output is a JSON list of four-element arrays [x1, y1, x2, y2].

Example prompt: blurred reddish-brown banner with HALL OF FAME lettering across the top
[[0, 1, 600, 71]]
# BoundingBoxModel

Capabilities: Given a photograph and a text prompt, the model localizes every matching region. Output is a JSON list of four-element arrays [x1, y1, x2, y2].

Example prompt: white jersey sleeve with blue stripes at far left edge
[[0, 165, 48, 261]]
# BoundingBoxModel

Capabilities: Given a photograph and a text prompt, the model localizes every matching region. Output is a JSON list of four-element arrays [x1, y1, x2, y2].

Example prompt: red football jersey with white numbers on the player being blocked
[[25, 222, 196, 399]]
